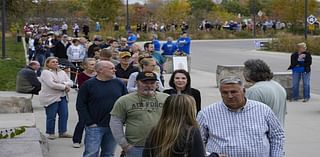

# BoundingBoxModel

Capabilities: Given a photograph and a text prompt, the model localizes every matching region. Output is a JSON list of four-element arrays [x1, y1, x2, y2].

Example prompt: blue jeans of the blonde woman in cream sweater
[[45, 97, 68, 134]]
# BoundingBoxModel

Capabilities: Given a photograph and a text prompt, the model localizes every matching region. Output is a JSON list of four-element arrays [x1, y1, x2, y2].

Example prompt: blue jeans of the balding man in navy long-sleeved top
[[83, 127, 117, 157]]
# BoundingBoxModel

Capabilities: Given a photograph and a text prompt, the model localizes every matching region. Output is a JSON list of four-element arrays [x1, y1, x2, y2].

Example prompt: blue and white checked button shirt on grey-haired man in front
[[197, 100, 284, 157]]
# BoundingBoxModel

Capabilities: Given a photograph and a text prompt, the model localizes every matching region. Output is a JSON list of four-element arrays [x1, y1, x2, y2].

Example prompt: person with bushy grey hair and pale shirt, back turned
[[243, 59, 287, 127]]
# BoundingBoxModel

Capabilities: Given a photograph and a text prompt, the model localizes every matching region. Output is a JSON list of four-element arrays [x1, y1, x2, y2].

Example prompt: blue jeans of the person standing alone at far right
[[292, 72, 311, 100]]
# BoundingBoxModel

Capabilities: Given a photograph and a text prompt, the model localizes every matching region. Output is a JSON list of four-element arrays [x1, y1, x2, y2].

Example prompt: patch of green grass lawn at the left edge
[[0, 37, 26, 91]]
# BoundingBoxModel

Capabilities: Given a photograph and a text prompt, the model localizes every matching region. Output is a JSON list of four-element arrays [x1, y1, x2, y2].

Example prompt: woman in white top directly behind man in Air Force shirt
[[127, 57, 164, 93]]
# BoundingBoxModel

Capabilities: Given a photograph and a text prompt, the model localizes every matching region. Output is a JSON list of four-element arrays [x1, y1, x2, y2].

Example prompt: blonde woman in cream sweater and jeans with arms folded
[[39, 57, 73, 140]]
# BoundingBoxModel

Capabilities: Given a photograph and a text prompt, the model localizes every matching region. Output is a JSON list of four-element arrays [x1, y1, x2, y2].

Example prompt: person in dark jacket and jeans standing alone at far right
[[288, 42, 312, 102]]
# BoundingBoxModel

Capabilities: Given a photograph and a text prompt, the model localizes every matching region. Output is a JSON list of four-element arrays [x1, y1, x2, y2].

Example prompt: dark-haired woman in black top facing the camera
[[163, 69, 201, 113]]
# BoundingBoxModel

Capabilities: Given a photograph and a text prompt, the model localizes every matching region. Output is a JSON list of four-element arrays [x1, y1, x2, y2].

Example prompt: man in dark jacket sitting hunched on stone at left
[[16, 61, 41, 95]]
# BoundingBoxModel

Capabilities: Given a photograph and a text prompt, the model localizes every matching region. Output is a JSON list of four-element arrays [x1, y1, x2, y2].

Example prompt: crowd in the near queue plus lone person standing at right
[[17, 20, 311, 157]]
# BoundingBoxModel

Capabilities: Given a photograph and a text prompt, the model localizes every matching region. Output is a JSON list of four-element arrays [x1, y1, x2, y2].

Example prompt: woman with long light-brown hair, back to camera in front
[[142, 94, 217, 157]]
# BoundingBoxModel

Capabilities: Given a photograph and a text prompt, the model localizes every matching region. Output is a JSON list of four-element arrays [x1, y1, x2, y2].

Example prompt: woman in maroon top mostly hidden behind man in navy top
[[72, 58, 97, 148]]
